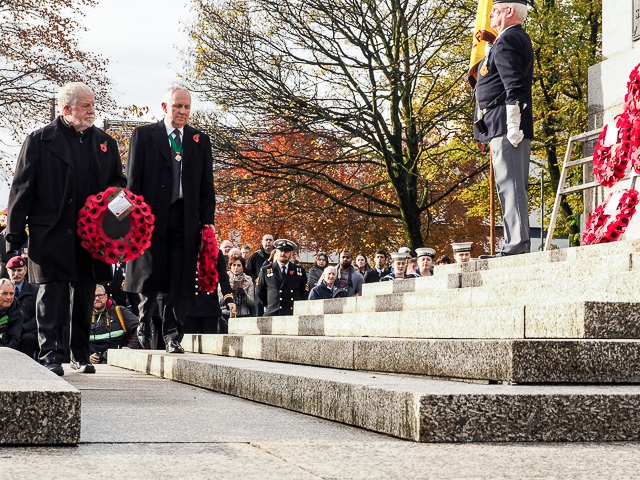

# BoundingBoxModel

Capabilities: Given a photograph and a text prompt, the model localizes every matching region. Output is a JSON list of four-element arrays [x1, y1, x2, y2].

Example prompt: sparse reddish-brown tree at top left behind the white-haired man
[[0, 0, 109, 134]]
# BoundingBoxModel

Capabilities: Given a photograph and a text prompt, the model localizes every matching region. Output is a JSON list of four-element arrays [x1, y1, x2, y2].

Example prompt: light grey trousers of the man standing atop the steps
[[490, 135, 531, 255]]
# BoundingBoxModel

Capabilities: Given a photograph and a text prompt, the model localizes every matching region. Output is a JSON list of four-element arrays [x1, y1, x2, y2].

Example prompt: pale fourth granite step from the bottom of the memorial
[[294, 272, 640, 316]]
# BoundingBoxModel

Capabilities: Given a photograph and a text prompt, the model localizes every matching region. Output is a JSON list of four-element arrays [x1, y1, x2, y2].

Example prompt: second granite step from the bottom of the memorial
[[182, 335, 640, 384]]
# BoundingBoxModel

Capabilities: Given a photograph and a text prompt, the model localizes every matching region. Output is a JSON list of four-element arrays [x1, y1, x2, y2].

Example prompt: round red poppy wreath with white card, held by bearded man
[[77, 187, 155, 263]]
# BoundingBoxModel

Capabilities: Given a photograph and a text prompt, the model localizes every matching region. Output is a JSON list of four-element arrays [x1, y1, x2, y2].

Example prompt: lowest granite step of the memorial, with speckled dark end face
[[109, 350, 640, 442]]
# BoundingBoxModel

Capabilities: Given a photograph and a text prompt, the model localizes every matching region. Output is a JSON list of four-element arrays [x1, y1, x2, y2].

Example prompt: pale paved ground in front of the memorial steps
[[0, 365, 640, 480]]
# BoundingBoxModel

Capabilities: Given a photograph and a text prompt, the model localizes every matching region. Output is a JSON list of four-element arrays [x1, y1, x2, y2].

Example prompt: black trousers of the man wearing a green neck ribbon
[[138, 199, 189, 343]]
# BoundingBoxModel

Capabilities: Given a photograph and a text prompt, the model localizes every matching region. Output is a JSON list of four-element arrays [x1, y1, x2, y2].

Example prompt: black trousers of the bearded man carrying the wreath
[[36, 246, 96, 364]]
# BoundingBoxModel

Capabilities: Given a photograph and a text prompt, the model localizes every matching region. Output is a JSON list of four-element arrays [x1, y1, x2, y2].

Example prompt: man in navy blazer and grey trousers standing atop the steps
[[474, 0, 533, 258]]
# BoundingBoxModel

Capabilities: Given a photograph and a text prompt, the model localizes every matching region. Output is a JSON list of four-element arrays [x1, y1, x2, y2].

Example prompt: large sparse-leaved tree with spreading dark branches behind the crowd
[[187, 0, 486, 248]]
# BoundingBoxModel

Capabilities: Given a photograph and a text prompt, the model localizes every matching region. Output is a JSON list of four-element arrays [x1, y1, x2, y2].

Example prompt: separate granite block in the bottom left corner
[[0, 348, 81, 445]]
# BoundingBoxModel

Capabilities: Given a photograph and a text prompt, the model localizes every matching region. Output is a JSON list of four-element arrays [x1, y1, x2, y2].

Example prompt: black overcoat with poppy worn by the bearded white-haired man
[[6, 117, 126, 283]]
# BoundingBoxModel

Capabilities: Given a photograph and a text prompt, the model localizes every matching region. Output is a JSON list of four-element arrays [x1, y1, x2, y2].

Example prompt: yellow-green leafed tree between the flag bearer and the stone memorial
[[526, 0, 602, 245]]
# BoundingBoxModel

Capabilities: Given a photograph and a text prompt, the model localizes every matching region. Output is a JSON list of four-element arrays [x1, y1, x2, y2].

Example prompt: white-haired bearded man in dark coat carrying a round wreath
[[6, 82, 126, 375]]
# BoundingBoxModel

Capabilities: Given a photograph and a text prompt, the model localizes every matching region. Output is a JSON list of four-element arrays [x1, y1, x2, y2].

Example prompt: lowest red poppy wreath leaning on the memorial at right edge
[[582, 190, 638, 245]]
